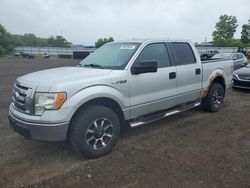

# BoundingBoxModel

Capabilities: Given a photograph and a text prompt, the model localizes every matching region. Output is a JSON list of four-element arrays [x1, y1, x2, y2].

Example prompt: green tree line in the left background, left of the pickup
[[0, 24, 71, 55]]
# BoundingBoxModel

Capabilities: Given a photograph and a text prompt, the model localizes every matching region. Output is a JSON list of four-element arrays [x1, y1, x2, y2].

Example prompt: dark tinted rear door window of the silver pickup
[[171, 42, 196, 65]]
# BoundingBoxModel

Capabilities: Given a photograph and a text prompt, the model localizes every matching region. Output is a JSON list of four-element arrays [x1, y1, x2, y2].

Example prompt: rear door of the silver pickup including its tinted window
[[170, 42, 202, 105]]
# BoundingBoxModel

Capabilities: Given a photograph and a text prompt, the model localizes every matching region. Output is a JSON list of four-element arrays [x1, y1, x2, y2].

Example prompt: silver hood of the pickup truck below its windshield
[[18, 67, 112, 92]]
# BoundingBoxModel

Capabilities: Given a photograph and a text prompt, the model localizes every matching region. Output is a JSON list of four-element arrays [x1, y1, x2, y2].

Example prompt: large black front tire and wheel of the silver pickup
[[69, 105, 120, 158]]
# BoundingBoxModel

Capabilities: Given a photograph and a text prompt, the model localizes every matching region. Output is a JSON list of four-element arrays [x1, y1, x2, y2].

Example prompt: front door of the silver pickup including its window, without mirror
[[129, 43, 176, 118]]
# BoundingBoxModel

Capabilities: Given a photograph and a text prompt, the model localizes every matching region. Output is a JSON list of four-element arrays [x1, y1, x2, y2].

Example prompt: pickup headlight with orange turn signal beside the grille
[[34, 93, 67, 115]]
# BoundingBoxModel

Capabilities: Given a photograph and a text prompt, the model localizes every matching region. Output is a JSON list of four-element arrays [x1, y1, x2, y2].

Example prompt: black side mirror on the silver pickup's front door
[[131, 61, 157, 74]]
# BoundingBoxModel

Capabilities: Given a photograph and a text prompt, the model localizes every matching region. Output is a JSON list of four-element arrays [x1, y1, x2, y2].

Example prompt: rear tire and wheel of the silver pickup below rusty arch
[[202, 83, 225, 112]]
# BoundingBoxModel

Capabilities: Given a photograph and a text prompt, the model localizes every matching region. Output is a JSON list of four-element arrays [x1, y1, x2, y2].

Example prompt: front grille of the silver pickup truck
[[12, 82, 32, 114]]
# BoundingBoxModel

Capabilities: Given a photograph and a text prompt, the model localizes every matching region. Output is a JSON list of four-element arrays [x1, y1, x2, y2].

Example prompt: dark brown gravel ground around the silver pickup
[[0, 58, 250, 188]]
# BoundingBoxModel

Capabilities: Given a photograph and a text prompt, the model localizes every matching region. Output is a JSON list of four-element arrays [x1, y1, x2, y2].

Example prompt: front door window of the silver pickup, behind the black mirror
[[138, 43, 171, 68]]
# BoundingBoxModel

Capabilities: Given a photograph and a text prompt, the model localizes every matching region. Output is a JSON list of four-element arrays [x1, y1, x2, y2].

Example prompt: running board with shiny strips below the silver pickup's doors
[[130, 102, 200, 128]]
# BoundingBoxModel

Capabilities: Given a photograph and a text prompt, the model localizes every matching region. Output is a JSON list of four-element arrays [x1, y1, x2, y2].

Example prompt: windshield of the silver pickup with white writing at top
[[79, 43, 140, 70]]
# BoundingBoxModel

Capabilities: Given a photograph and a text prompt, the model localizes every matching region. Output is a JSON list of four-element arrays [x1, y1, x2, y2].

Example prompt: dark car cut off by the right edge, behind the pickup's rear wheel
[[233, 64, 250, 89]]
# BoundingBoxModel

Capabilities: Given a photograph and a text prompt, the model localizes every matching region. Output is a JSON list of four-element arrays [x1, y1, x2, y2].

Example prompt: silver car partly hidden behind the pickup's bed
[[211, 53, 248, 70]]
